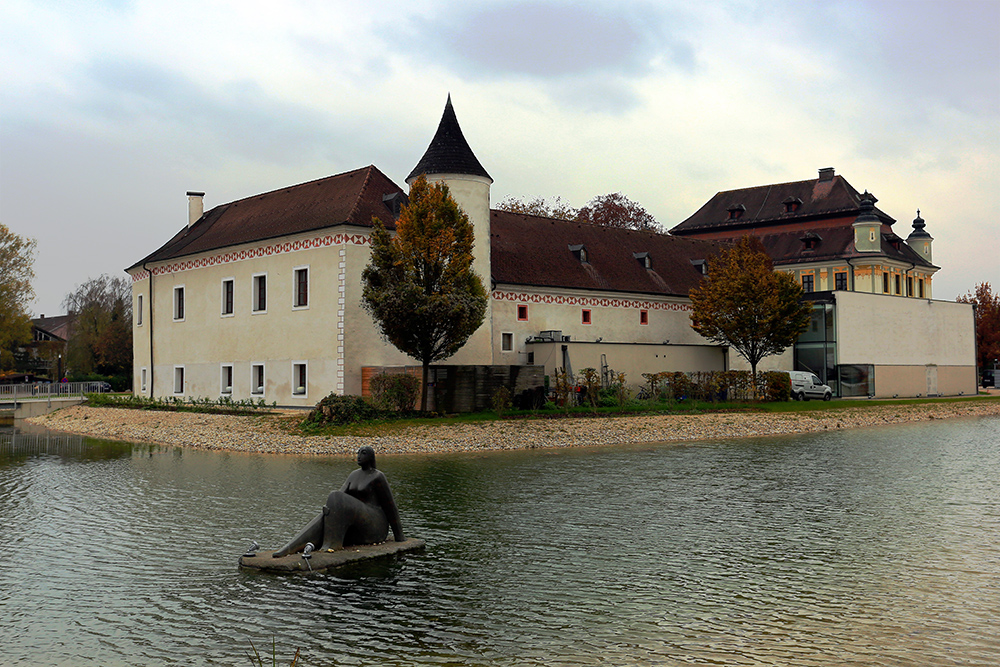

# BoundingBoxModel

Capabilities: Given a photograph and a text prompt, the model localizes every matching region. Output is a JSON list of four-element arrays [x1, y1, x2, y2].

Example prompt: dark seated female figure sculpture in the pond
[[273, 447, 406, 558]]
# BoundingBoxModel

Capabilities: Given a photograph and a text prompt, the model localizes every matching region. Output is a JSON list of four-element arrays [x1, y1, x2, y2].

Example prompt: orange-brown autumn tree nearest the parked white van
[[691, 235, 812, 396]]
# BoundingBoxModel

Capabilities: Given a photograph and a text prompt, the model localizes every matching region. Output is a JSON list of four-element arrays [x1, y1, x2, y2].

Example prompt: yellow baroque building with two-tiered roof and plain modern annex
[[670, 168, 976, 397]]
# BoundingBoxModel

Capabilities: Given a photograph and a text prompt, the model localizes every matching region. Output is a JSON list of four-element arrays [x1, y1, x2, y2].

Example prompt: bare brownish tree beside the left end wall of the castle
[[63, 274, 132, 390]]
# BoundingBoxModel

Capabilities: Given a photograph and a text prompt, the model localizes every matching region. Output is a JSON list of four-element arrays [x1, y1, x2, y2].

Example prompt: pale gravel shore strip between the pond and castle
[[28, 399, 1000, 455]]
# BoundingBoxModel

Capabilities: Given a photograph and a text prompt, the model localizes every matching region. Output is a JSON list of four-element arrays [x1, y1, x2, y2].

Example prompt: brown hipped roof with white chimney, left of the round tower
[[129, 166, 406, 269]]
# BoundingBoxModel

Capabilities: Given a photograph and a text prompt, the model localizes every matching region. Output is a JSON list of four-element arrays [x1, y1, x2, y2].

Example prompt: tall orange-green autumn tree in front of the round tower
[[361, 176, 487, 411]]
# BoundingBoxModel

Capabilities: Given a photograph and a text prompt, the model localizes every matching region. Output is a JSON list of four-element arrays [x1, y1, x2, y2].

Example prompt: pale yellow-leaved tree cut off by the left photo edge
[[0, 223, 35, 370]]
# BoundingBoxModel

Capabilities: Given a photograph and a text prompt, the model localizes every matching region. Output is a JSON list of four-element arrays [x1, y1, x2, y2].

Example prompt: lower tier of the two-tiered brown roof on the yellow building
[[759, 226, 937, 268]]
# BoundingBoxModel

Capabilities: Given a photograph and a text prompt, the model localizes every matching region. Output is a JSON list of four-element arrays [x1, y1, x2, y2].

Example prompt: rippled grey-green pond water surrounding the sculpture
[[0, 418, 1000, 666]]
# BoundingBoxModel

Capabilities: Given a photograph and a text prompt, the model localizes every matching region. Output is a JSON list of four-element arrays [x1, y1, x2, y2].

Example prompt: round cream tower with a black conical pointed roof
[[406, 94, 493, 364]]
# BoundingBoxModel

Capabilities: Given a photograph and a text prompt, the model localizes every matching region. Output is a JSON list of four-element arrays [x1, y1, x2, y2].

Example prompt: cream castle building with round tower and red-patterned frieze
[[127, 97, 727, 407]]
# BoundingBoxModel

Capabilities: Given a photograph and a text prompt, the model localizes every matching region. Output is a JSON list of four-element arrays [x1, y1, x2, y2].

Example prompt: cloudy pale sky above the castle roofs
[[0, 0, 1000, 316]]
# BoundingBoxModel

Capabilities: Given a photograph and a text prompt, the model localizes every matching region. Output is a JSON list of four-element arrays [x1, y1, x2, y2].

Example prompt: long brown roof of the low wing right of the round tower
[[490, 211, 720, 296]]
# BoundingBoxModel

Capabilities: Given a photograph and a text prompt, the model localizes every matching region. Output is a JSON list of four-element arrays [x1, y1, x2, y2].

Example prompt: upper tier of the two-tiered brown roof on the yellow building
[[670, 171, 895, 236]]
